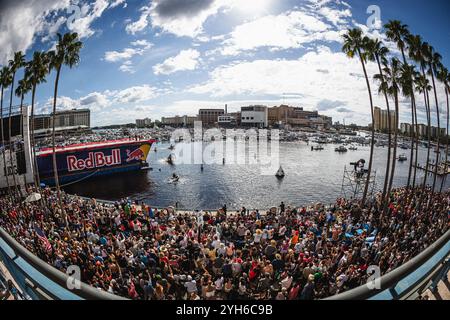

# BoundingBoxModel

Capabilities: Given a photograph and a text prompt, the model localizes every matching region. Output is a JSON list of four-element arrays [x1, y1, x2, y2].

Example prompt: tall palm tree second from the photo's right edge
[[425, 44, 442, 194]]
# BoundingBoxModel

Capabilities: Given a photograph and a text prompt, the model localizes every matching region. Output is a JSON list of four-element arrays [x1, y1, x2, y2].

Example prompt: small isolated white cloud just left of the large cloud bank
[[153, 49, 200, 75]]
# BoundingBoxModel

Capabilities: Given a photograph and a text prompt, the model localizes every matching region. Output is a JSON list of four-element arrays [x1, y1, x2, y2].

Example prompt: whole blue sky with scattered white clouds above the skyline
[[0, 0, 450, 125]]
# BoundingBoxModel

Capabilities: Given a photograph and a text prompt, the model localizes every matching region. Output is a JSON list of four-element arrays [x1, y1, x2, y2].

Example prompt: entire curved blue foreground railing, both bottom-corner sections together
[[0, 227, 450, 300]]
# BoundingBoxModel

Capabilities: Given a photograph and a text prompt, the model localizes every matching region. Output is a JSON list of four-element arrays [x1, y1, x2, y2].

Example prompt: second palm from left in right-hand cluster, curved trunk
[[367, 39, 392, 201]]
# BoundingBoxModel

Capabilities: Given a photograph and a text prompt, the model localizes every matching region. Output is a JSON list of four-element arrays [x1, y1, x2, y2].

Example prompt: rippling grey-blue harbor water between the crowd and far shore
[[64, 141, 450, 210]]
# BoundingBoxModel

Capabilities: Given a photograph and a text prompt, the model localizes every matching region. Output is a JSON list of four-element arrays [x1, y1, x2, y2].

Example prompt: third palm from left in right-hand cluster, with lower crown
[[383, 58, 402, 196]]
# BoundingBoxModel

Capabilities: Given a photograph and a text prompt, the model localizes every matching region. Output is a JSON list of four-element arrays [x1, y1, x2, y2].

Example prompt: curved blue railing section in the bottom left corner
[[0, 227, 124, 300]]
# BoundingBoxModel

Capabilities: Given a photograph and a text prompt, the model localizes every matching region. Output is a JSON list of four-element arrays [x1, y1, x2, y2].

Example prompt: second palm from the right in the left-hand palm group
[[25, 52, 49, 188]]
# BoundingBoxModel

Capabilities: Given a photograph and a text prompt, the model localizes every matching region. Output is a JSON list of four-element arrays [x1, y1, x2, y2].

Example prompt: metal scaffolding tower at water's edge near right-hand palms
[[341, 166, 377, 199]]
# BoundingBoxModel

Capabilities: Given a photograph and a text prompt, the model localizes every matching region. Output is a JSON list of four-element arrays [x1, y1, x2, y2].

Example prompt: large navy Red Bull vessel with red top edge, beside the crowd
[[36, 138, 156, 186]]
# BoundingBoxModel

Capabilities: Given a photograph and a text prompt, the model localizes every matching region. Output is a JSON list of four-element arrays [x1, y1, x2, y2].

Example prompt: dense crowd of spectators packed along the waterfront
[[0, 188, 450, 300]]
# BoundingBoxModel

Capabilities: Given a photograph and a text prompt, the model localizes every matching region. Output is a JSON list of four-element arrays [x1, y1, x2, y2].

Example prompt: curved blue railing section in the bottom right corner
[[326, 230, 450, 300]]
